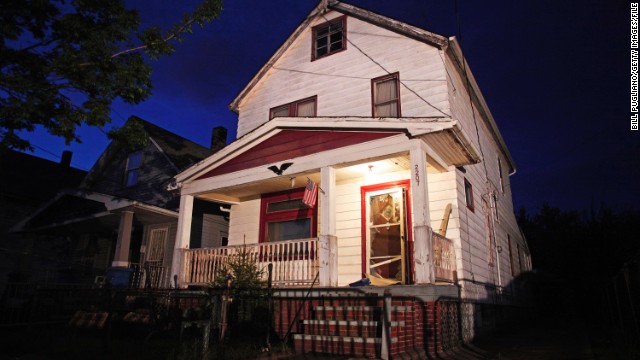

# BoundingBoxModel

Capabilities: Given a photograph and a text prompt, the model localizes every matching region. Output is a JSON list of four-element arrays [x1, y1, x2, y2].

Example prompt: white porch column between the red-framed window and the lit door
[[318, 166, 338, 286]]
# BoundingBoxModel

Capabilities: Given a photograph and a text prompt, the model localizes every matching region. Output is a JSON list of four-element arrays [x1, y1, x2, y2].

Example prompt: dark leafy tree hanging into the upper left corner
[[0, 0, 222, 150]]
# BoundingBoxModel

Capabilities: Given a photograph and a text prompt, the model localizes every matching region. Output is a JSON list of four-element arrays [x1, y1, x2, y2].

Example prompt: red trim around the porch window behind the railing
[[258, 188, 318, 243]]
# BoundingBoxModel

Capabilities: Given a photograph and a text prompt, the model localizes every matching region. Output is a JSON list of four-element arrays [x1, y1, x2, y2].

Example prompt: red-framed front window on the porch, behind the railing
[[260, 188, 317, 242]]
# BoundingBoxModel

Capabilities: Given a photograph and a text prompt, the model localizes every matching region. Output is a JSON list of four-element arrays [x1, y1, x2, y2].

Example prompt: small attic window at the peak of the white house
[[311, 16, 347, 61]]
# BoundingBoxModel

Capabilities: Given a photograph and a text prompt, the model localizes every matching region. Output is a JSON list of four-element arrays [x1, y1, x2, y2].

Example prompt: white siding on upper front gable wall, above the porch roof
[[237, 12, 449, 137]]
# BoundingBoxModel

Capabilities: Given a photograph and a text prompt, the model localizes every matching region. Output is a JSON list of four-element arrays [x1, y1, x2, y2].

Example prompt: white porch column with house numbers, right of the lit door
[[409, 139, 435, 284]]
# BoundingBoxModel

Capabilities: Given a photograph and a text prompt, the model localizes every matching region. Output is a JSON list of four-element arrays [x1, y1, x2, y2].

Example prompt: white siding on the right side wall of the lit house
[[446, 53, 524, 301]]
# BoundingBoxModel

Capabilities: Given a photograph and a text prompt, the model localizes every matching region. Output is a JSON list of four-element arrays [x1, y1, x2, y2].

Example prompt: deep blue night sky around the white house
[[17, 0, 640, 212]]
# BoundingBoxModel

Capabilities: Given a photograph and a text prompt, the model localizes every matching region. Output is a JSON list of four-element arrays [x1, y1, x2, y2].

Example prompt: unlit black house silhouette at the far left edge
[[0, 148, 87, 283]]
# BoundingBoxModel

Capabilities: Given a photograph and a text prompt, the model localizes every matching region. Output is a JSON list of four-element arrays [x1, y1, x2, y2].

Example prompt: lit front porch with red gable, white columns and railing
[[171, 118, 477, 287]]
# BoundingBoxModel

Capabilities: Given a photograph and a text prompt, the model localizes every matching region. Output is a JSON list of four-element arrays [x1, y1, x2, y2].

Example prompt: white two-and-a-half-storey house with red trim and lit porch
[[172, 2, 531, 356]]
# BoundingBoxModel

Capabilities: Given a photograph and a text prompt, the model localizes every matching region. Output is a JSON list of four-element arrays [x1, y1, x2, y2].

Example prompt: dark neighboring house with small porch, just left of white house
[[13, 117, 227, 287]]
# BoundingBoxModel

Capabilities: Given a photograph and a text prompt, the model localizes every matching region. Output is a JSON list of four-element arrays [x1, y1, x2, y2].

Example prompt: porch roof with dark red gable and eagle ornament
[[176, 117, 480, 203]]
